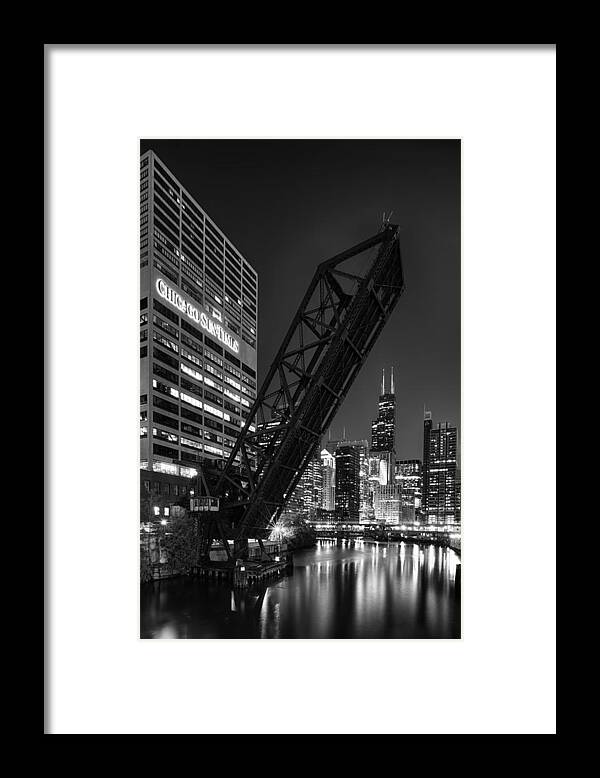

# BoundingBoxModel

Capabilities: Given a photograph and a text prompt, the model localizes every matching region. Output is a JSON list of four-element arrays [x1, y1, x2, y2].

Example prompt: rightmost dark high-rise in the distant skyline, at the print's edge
[[423, 413, 460, 528]]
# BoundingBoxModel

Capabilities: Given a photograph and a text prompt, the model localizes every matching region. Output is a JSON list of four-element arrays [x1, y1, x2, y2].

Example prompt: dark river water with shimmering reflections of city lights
[[140, 540, 460, 638]]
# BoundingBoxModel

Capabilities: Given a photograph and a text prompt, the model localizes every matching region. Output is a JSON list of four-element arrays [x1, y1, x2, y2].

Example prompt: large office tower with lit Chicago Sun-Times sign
[[140, 151, 258, 498]]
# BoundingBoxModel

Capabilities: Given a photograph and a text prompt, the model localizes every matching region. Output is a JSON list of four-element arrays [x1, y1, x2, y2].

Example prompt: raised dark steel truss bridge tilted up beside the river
[[199, 224, 404, 560]]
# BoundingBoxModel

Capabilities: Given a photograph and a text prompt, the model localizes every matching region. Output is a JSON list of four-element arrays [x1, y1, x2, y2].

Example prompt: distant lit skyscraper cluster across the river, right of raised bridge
[[283, 358, 461, 532]]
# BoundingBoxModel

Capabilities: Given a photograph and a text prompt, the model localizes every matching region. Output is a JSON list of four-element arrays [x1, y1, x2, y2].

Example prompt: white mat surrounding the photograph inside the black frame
[[46, 45, 556, 734]]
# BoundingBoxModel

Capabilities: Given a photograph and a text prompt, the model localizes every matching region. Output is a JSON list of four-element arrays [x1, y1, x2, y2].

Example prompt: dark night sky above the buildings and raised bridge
[[141, 140, 461, 459]]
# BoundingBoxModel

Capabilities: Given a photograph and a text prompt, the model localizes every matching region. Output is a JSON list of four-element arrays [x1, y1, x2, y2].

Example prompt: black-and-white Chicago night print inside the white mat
[[140, 139, 461, 638]]
